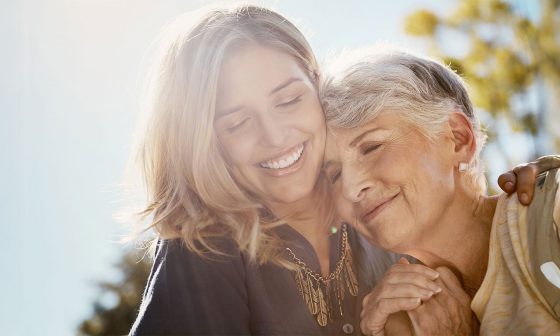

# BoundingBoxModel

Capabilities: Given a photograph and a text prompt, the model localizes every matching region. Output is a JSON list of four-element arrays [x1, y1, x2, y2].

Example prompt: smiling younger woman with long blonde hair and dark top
[[131, 6, 548, 335]]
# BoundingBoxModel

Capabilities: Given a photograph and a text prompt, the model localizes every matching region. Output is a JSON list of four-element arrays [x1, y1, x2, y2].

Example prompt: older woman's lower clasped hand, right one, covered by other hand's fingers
[[408, 267, 479, 336]]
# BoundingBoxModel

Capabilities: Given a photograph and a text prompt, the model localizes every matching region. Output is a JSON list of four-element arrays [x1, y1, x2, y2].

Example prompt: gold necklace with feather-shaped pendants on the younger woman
[[286, 224, 358, 327]]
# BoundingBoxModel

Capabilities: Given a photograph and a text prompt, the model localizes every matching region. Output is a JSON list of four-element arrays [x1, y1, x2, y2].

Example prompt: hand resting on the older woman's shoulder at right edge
[[498, 155, 560, 205]]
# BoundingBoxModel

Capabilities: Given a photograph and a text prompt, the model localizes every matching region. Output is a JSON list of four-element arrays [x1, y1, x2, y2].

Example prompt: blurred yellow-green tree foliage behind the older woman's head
[[405, 0, 560, 161]]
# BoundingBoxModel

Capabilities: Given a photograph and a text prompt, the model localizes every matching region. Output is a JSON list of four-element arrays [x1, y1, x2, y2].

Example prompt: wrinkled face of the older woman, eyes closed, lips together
[[325, 112, 454, 253]]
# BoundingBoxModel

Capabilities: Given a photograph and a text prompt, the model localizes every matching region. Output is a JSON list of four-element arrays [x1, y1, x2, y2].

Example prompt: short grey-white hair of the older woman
[[321, 46, 486, 193]]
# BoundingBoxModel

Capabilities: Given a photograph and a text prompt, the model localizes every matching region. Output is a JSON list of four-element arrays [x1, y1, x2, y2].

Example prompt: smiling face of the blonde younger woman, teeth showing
[[214, 45, 326, 204]]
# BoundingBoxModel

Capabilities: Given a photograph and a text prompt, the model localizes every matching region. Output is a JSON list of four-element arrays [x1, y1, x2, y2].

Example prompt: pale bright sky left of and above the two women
[[0, 0, 540, 336]]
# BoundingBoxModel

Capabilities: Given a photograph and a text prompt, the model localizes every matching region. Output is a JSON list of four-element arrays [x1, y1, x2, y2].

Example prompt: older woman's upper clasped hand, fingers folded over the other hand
[[360, 258, 442, 336]]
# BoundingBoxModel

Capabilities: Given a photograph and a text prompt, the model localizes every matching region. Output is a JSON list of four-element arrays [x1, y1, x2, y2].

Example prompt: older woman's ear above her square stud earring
[[447, 112, 476, 166]]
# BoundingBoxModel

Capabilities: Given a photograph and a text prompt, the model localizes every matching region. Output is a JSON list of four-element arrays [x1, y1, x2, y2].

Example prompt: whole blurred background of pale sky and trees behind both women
[[0, 0, 560, 336]]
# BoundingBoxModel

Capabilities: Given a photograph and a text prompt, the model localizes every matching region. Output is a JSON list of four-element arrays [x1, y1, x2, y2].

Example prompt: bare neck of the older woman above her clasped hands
[[406, 190, 497, 297]]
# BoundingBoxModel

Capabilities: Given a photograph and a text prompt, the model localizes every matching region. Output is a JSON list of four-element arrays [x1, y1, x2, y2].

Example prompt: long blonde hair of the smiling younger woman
[[133, 6, 318, 263]]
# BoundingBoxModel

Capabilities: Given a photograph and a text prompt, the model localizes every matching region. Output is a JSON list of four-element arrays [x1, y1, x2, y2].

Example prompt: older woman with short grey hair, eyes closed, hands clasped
[[323, 51, 560, 335]]
